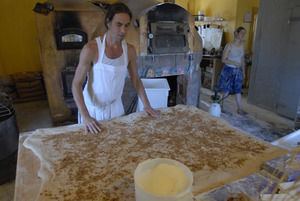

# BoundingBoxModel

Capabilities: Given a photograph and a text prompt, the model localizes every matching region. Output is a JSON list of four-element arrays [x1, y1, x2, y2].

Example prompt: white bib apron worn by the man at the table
[[78, 35, 128, 123]]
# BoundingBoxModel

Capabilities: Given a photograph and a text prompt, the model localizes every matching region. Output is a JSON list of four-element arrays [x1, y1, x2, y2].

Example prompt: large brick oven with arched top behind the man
[[35, 0, 202, 125]]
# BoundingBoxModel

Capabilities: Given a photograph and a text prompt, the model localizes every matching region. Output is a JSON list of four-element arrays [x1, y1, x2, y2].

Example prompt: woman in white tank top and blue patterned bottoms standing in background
[[219, 27, 247, 115]]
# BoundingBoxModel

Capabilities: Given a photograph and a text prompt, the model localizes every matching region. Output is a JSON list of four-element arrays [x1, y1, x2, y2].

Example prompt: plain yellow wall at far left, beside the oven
[[0, 0, 42, 75]]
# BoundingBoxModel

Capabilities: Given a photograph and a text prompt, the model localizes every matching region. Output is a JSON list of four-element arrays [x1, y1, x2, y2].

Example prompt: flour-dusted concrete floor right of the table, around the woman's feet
[[200, 88, 295, 142]]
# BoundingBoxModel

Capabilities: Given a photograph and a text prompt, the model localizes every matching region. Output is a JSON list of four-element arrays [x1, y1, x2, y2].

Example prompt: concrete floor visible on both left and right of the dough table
[[0, 88, 294, 201]]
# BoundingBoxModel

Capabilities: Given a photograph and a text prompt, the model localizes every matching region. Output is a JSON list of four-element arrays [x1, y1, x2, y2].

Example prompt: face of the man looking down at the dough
[[107, 13, 130, 41]]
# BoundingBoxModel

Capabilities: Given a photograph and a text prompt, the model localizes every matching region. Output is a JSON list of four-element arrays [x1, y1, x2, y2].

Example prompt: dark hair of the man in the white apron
[[104, 3, 132, 29]]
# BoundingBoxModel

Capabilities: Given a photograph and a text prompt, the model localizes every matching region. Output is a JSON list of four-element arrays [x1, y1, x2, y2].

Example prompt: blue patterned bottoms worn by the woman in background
[[219, 65, 243, 94]]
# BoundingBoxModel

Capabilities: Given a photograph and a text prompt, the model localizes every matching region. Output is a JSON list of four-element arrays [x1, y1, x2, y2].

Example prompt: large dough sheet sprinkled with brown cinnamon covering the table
[[24, 105, 287, 201]]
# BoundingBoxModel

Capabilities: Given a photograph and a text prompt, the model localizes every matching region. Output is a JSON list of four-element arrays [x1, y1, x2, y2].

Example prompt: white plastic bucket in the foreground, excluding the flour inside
[[134, 158, 194, 201]]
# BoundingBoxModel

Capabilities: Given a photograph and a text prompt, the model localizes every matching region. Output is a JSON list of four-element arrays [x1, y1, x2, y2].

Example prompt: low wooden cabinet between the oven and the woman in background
[[200, 55, 224, 90]]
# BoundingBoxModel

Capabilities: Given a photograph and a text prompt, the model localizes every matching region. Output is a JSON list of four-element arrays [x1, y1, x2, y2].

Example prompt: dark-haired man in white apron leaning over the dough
[[72, 3, 160, 133]]
